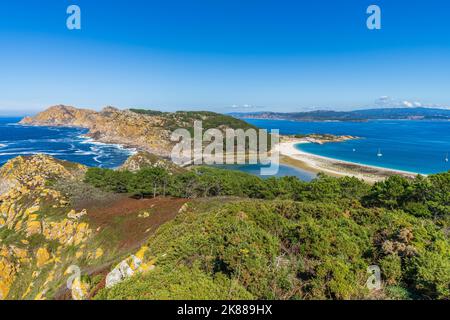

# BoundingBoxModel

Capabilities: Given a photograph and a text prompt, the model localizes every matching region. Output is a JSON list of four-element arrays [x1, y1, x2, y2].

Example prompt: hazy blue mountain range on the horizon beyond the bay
[[230, 108, 450, 121]]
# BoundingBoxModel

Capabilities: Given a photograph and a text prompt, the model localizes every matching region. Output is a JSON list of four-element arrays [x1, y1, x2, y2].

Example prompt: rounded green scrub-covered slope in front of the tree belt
[[96, 200, 449, 299]]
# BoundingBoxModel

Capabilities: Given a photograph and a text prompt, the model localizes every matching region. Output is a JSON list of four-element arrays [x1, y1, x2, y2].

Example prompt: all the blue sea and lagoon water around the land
[[0, 118, 450, 180]]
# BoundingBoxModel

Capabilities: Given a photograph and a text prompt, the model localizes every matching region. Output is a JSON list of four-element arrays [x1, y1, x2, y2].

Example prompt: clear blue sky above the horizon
[[0, 0, 450, 114]]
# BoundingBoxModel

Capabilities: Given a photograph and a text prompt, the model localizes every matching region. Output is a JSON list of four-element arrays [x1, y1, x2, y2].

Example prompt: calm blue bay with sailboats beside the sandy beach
[[246, 119, 450, 174]]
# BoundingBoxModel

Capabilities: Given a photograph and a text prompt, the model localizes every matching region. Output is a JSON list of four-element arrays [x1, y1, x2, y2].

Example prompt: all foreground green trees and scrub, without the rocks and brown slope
[[86, 167, 450, 299]]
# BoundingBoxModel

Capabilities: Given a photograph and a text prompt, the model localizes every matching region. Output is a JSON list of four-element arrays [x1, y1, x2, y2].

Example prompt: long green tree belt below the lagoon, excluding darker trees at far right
[[85, 167, 369, 201]]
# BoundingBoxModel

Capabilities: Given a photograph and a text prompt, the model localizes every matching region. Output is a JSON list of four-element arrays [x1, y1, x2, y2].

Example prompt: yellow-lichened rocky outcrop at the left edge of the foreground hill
[[0, 155, 96, 299]]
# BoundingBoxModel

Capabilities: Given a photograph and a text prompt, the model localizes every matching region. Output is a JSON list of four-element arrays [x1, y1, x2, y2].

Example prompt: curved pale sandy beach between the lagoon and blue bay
[[277, 139, 417, 183]]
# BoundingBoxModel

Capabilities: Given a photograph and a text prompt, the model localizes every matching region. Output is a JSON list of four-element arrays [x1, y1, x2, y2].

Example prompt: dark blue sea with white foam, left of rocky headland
[[0, 118, 135, 168]]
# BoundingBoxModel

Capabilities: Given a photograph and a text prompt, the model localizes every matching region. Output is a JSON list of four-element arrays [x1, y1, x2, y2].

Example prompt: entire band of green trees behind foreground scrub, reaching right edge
[[85, 167, 450, 219]]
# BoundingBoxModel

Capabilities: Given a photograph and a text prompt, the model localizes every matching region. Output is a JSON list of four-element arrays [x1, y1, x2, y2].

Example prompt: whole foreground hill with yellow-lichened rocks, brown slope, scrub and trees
[[0, 154, 450, 299]]
